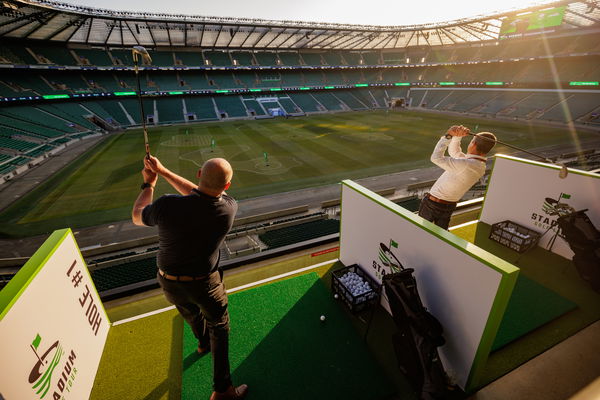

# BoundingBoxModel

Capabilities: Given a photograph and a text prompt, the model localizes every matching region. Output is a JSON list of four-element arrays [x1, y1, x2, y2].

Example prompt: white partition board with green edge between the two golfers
[[340, 181, 519, 389]]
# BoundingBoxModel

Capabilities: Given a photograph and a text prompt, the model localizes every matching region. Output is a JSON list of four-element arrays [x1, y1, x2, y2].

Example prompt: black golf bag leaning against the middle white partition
[[383, 268, 448, 400]]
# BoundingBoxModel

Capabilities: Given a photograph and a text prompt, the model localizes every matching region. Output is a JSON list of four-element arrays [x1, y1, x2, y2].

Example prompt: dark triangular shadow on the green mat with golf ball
[[227, 280, 394, 400]]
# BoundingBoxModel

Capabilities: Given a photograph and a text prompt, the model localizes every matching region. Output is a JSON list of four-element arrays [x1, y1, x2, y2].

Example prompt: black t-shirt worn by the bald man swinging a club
[[142, 189, 237, 276]]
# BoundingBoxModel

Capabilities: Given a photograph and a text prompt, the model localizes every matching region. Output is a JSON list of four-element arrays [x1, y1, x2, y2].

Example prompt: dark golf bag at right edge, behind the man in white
[[557, 209, 600, 293]]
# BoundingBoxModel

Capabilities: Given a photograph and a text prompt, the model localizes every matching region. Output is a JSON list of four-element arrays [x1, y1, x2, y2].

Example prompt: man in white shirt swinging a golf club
[[419, 125, 496, 229]]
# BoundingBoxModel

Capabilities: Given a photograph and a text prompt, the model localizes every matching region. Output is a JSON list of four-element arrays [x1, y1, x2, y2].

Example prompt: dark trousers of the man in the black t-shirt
[[158, 271, 231, 392]]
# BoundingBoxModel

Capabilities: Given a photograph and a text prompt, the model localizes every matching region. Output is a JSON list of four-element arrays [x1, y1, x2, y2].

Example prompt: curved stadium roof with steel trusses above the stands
[[0, 0, 600, 50]]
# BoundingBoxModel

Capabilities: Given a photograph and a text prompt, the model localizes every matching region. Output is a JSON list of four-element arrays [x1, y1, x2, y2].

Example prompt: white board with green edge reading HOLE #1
[[0, 229, 110, 400]]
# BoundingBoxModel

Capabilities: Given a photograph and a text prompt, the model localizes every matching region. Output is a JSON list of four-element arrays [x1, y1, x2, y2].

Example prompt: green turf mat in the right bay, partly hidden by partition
[[492, 275, 577, 351]]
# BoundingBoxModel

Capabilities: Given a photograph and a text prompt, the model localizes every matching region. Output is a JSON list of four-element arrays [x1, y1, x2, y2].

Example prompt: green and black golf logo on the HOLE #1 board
[[29, 333, 77, 400]]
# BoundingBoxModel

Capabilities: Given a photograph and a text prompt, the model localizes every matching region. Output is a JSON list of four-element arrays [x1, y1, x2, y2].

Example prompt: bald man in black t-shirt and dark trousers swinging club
[[131, 156, 248, 400]]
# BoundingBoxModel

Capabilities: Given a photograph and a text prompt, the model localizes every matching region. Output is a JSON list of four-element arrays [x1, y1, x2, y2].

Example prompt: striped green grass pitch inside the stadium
[[0, 110, 594, 237]]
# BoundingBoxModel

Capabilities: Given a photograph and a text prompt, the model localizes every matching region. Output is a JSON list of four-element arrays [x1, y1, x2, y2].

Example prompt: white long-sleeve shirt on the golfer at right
[[429, 136, 486, 201]]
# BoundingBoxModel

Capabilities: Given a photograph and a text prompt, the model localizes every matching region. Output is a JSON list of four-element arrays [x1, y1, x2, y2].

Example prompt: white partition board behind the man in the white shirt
[[479, 155, 600, 259]]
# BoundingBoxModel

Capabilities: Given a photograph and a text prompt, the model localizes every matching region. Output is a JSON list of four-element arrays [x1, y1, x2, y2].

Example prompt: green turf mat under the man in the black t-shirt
[[182, 273, 394, 400]]
